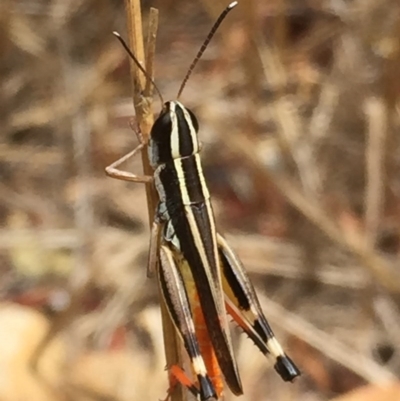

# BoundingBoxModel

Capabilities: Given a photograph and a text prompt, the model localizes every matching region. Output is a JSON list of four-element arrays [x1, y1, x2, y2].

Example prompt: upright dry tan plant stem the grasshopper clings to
[[125, 0, 185, 401]]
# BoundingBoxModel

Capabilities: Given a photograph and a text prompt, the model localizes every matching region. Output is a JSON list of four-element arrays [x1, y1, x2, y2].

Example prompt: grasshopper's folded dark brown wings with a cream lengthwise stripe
[[168, 199, 243, 395]]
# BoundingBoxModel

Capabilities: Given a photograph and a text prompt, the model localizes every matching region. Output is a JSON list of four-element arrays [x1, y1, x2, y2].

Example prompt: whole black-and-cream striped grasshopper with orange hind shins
[[106, 1, 300, 401]]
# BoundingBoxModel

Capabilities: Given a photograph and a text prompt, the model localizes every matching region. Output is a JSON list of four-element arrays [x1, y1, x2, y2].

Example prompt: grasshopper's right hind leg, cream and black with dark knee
[[217, 234, 300, 381]]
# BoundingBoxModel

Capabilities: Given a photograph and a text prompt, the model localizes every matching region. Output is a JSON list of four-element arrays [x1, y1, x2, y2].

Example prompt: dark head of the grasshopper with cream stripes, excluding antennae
[[148, 101, 199, 168]]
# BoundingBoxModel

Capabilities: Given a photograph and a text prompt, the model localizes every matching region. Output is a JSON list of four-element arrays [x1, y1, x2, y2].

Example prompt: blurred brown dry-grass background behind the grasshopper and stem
[[0, 0, 400, 401]]
